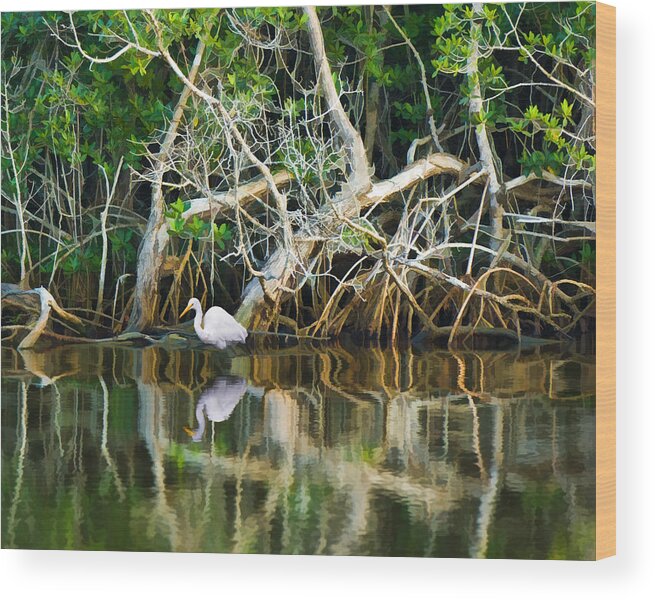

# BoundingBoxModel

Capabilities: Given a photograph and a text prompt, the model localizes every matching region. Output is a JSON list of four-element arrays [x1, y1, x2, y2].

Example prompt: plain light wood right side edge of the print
[[596, 3, 616, 559]]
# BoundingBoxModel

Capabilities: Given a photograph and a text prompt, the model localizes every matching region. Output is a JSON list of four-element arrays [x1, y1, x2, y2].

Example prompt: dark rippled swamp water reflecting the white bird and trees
[[2, 345, 595, 559]]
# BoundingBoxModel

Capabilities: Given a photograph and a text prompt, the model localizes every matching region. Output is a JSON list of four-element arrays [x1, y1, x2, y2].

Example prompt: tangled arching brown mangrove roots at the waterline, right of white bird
[[245, 159, 595, 344]]
